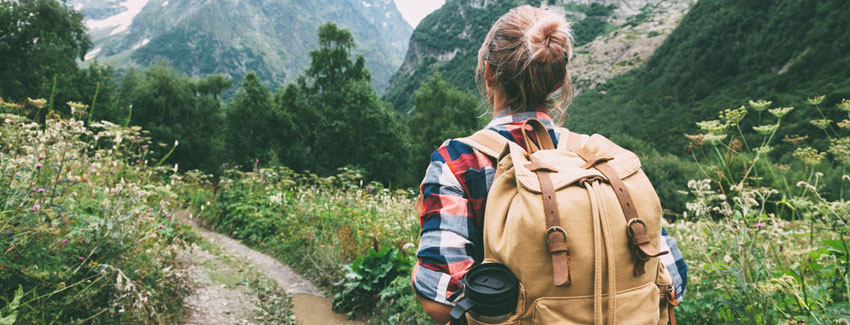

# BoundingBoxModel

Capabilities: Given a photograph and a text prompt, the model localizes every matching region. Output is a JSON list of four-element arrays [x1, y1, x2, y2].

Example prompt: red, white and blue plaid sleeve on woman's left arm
[[412, 146, 479, 305]]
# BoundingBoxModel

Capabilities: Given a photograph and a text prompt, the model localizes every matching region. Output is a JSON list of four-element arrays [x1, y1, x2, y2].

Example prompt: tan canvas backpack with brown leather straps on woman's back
[[459, 119, 677, 325]]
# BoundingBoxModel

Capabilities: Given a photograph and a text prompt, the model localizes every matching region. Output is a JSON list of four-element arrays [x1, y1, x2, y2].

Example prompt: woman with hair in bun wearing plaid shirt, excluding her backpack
[[413, 6, 686, 323]]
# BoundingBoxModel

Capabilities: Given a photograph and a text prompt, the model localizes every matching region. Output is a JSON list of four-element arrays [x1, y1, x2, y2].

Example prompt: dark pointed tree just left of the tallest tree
[[227, 72, 277, 169]]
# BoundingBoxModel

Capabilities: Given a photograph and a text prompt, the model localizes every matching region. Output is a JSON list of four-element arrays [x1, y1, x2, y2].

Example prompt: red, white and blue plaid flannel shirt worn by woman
[[412, 112, 688, 305]]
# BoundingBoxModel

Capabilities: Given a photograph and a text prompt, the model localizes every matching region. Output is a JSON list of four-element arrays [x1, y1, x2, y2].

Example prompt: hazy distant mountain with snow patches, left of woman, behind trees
[[74, 0, 412, 90]]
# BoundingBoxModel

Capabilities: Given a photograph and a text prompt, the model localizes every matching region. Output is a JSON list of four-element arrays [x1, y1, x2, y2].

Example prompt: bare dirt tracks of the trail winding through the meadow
[[181, 215, 364, 325]]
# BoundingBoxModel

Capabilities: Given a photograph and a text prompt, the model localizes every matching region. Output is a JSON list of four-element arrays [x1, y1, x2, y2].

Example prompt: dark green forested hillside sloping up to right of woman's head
[[567, 0, 850, 153]]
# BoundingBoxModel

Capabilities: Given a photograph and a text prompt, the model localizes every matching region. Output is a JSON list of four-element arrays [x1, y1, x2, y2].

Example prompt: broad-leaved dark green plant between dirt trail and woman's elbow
[[333, 248, 416, 315]]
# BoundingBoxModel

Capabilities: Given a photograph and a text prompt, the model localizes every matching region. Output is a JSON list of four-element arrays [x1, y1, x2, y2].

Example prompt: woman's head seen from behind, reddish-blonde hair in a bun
[[475, 6, 572, 118]]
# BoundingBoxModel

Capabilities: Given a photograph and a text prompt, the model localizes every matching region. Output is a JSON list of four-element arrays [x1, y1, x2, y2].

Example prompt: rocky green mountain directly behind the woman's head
[[385, 0, 696, 111]]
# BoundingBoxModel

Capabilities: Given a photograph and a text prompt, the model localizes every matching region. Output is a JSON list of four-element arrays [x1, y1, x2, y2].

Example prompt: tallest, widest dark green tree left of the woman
[[276, 23, 412, 185]]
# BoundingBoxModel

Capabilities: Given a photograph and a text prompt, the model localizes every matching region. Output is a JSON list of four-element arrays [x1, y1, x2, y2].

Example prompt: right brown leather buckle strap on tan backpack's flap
[[567, 132, 669, 276]]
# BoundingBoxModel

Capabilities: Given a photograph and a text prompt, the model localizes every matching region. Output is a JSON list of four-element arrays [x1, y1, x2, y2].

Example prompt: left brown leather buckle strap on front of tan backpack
[[527, 156, 572, 287]]
